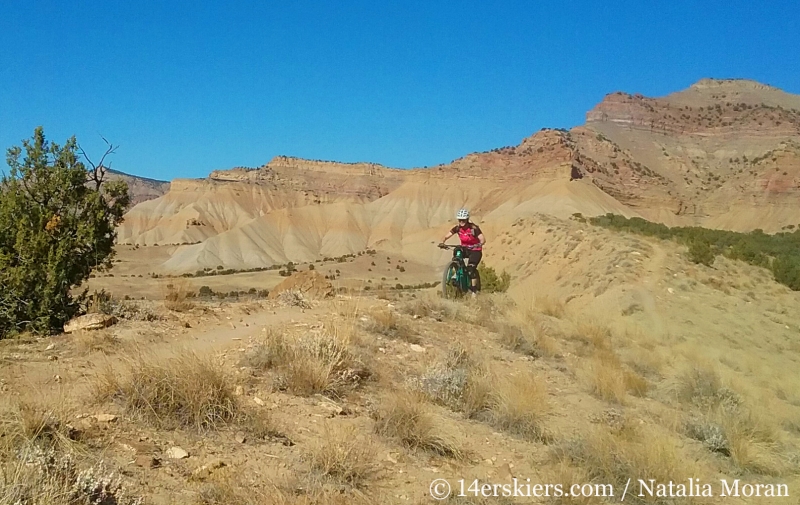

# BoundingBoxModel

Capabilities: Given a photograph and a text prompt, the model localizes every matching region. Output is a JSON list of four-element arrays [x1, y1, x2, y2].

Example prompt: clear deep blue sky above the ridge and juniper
[[0, 0, 800, 180]]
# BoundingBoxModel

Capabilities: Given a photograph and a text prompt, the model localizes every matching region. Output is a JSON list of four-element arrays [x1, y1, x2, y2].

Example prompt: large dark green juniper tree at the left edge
[[0, 127, 130, 338]]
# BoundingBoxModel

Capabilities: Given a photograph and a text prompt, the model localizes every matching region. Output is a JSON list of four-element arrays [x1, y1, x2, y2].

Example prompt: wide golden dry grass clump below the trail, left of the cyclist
[[242, 330, 371, 398]]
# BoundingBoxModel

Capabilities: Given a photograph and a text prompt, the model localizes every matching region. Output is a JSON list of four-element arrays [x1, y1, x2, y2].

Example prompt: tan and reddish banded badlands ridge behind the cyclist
[[119, 80, 800, 272]]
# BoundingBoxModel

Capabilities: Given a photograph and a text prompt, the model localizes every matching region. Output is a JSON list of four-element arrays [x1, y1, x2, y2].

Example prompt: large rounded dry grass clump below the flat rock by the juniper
[[94, 354, 241, 430]]
